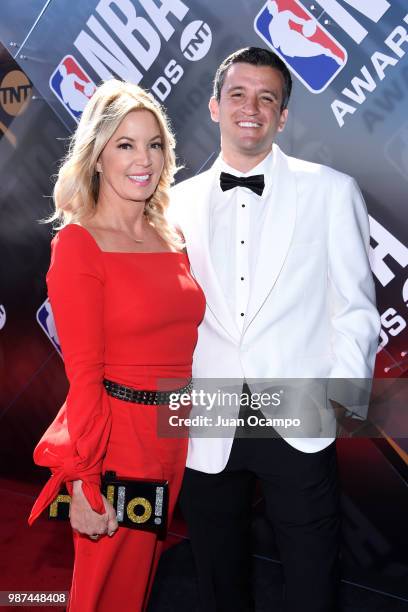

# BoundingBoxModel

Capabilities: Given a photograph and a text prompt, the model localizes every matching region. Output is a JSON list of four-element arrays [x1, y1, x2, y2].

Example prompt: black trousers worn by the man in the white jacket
[[180, 390, 339, 612]]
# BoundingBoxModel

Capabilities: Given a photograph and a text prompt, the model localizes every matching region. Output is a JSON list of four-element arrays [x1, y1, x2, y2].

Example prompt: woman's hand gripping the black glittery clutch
[[69, 480, 118, 539]]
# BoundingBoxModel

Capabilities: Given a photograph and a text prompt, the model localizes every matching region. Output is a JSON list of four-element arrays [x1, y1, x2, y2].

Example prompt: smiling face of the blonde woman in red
[[96, 110, 164, 212]]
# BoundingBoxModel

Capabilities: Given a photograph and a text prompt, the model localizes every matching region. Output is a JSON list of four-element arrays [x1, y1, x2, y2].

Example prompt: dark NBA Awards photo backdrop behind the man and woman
[[0, 0, 408, 597]]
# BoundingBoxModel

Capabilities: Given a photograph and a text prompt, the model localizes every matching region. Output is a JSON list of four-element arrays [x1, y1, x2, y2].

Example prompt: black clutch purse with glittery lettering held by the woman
[[48, 472, 169, 540]]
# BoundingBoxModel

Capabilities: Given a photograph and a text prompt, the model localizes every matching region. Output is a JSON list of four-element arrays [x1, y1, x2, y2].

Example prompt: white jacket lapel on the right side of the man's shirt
[[244, 145, 297, 334]]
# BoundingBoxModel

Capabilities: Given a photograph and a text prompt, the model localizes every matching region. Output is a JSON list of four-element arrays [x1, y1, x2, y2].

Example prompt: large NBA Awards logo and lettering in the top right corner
[[254, 0, 408, 127]]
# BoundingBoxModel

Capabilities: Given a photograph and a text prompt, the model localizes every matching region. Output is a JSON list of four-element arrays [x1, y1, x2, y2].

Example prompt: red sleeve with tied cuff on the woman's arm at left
[[29, 226, 111, 525]]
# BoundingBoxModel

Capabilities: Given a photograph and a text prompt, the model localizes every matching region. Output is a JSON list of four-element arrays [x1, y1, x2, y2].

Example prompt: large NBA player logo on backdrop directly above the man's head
[[254, 0, 347, 93]]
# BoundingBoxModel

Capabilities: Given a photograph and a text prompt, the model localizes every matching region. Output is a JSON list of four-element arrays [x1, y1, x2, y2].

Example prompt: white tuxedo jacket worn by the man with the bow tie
[[170, 145, 380, 473]]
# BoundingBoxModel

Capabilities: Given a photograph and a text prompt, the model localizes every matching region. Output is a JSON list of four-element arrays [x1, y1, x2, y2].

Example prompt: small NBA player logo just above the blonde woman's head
[[50, 55, 95, 121]]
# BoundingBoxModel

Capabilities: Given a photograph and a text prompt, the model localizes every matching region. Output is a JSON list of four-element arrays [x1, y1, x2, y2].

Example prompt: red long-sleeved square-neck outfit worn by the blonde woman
[[29, 225, 205, 612]]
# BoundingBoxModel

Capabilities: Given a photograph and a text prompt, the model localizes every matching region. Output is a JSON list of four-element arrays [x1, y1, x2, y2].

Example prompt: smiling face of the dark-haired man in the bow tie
[[210, 62, 288, 172]]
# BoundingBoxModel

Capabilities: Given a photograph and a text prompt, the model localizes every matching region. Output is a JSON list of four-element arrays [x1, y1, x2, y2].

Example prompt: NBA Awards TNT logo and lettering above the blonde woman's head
[[49, 0, 212, 121]]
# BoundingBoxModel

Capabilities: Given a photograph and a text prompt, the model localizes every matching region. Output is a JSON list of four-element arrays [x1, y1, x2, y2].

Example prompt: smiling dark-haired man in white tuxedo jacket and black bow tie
[[172, 47, 379, 612]]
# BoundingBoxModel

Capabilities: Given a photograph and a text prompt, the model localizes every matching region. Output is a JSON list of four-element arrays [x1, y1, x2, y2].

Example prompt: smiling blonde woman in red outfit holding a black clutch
[[29, 80, 204, 612]]
